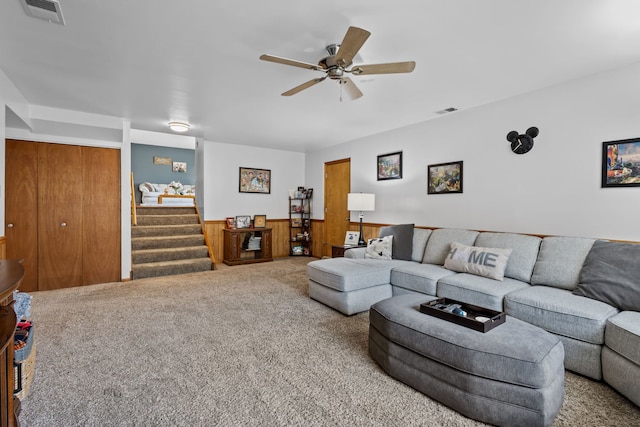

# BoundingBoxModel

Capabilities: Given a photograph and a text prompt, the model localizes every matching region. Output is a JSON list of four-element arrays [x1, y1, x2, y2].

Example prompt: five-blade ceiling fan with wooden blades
[[260, 27, 416, 100]]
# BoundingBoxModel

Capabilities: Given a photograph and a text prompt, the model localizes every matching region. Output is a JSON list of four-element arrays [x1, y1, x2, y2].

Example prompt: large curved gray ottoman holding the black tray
[[369, 295, 564, 426]]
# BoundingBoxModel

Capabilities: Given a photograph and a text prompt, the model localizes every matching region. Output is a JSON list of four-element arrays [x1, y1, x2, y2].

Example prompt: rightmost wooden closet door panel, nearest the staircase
[[82, 147, 120, 285]]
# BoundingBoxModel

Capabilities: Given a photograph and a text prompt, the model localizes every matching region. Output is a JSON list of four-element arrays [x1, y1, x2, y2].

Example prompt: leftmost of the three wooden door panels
[[4, 139, 38, 292]]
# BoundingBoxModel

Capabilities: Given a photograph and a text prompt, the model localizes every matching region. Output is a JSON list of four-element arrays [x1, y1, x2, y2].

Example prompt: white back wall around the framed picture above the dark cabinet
[[203, 141, 305, 221]]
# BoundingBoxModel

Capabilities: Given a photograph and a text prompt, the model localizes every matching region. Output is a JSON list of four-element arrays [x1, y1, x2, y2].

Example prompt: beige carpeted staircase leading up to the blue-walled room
[[131, 206, 213, 279]]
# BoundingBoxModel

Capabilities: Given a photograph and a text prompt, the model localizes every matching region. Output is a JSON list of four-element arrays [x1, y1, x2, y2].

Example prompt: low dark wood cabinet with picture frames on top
[[222, 228, 273, 265]]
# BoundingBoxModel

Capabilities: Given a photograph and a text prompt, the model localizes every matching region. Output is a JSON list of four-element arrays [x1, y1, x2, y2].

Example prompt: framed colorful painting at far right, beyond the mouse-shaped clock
[[602, 138, 640, 188]]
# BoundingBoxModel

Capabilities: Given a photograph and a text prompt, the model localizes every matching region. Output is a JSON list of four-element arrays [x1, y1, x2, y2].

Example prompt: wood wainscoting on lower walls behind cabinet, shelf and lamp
[[204, 218, 386, 262]]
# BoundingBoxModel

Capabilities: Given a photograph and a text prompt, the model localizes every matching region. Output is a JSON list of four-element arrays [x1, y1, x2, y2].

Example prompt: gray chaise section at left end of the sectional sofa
[[307, 258, 397, 316]]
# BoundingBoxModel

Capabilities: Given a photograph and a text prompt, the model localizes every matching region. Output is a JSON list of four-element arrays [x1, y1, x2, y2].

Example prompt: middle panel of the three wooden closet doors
[[38, 144, 83, 291]]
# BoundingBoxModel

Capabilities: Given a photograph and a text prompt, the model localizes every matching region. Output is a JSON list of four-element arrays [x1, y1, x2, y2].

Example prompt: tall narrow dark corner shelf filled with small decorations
[[289, 187, 313, 256]]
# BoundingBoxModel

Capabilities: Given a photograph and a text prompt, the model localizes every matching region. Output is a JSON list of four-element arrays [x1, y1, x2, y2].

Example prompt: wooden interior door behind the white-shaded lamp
[[322, 159, 351, 256]]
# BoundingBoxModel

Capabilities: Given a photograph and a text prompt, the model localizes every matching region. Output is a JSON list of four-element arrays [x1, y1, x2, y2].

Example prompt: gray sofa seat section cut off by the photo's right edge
[[604, 311, 640, 365]]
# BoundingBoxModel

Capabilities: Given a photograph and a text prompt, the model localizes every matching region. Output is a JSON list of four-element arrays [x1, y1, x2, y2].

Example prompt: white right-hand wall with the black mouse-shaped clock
[[306, 60, 640, 241]]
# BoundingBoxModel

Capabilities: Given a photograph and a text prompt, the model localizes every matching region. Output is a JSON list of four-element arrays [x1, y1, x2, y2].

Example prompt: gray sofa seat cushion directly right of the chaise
[[391, 262, 456, 295]]
